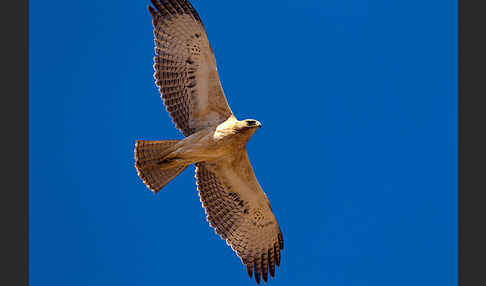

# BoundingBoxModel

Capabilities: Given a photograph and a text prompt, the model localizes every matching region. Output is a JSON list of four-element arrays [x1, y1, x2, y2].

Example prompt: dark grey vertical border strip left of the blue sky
[[0, 0, 29, 285]]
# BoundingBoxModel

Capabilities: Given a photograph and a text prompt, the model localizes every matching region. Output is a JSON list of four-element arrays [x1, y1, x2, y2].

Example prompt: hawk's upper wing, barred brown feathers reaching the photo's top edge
[[148, 0, 232, 136]]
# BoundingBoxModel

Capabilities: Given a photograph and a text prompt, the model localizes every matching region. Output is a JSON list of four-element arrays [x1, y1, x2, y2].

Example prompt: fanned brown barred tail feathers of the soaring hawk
[[135, 140, 188, 193]]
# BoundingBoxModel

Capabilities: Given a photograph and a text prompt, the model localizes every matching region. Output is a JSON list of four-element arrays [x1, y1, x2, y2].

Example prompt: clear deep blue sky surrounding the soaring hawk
[[29, 0, 457, 286]]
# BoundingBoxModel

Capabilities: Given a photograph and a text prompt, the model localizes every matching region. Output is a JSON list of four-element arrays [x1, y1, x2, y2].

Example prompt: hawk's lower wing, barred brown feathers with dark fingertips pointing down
[[196, 150, 283, 283]]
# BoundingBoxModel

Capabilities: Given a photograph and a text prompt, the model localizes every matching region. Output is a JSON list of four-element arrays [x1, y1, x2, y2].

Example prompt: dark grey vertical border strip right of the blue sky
[[458, 0, 486, 286]]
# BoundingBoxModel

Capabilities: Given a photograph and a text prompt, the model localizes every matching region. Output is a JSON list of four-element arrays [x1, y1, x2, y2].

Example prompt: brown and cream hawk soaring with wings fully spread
[[135, 0, 283, 284]]
